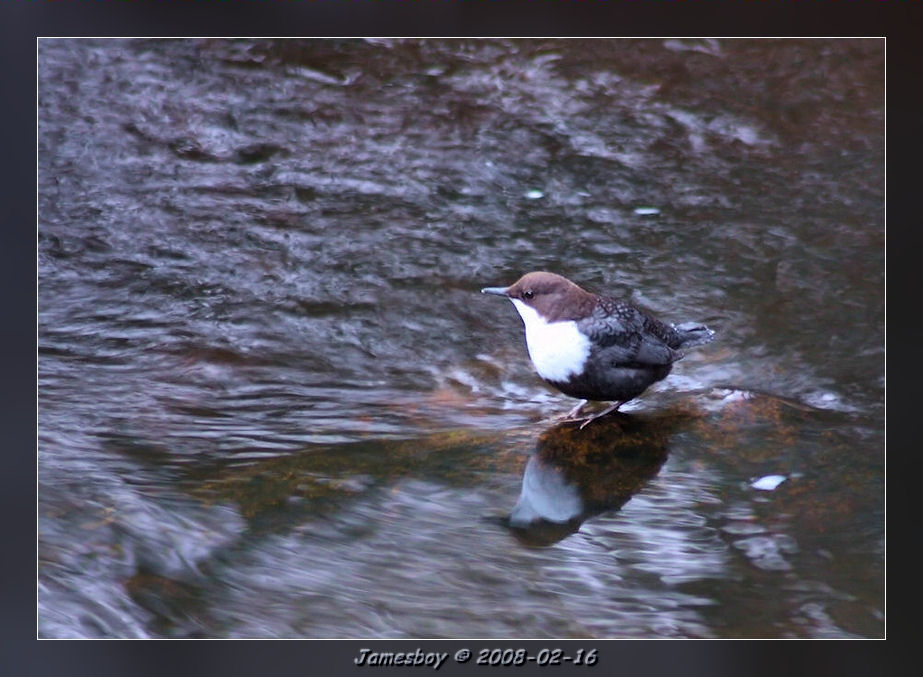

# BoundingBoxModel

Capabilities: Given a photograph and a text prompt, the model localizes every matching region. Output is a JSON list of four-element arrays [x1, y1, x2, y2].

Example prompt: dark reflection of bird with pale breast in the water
[[506, 412, 689, 546]]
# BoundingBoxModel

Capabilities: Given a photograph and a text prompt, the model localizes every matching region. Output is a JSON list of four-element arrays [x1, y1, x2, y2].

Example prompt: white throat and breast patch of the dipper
[[510, 299, 590, 381]]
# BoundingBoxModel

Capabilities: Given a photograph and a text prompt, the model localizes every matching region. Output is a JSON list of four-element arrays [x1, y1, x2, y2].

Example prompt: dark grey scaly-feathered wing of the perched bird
[[578, 297, 683, 366]]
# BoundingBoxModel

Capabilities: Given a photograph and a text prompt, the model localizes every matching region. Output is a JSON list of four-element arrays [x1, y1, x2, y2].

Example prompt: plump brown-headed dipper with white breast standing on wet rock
[[481, 271, 715, 428]]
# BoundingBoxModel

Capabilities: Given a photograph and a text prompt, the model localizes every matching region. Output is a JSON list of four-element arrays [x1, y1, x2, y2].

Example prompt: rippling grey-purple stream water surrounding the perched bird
[[37, 39, 885, 638]]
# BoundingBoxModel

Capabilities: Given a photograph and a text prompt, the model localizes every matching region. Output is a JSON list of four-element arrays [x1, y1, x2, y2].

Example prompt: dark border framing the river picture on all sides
[[7, 0, 904, 675]]
